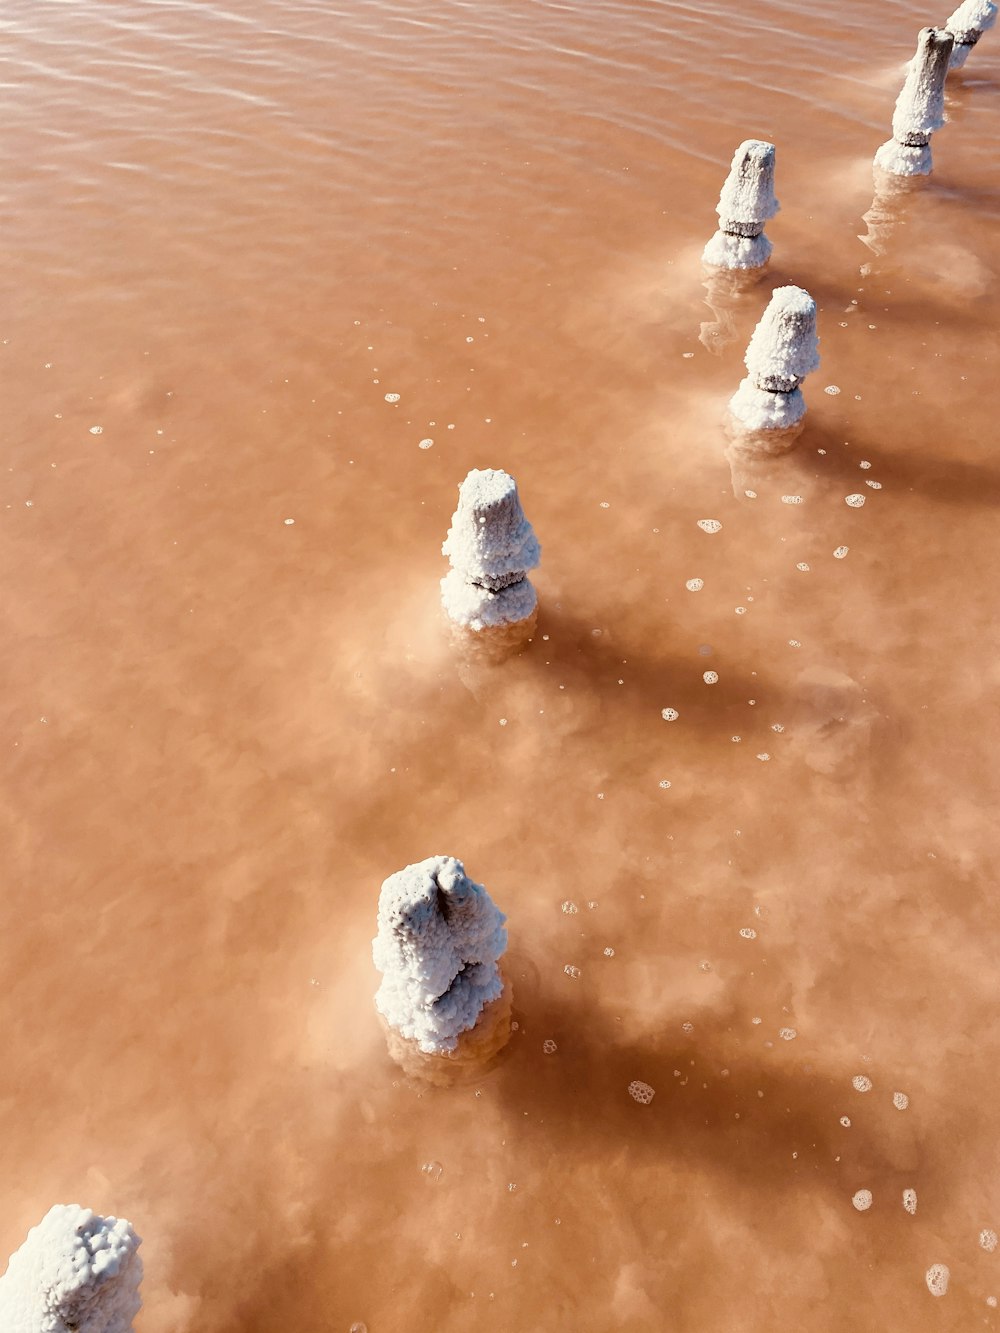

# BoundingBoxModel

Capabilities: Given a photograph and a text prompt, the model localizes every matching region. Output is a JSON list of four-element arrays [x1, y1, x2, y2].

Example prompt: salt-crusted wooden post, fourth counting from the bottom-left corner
[[729, 287, 820, 431]]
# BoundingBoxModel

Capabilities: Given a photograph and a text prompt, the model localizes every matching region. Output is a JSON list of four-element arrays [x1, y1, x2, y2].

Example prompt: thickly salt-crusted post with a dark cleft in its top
[[372, 856, 507, 1054]]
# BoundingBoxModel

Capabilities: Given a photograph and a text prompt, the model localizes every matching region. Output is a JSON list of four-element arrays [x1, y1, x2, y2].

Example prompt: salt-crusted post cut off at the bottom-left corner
[[0, 1204, 143, 1333]]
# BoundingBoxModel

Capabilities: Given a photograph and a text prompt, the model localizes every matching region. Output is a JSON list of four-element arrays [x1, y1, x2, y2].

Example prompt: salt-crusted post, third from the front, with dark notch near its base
[[441, 468, 541, 631]]
